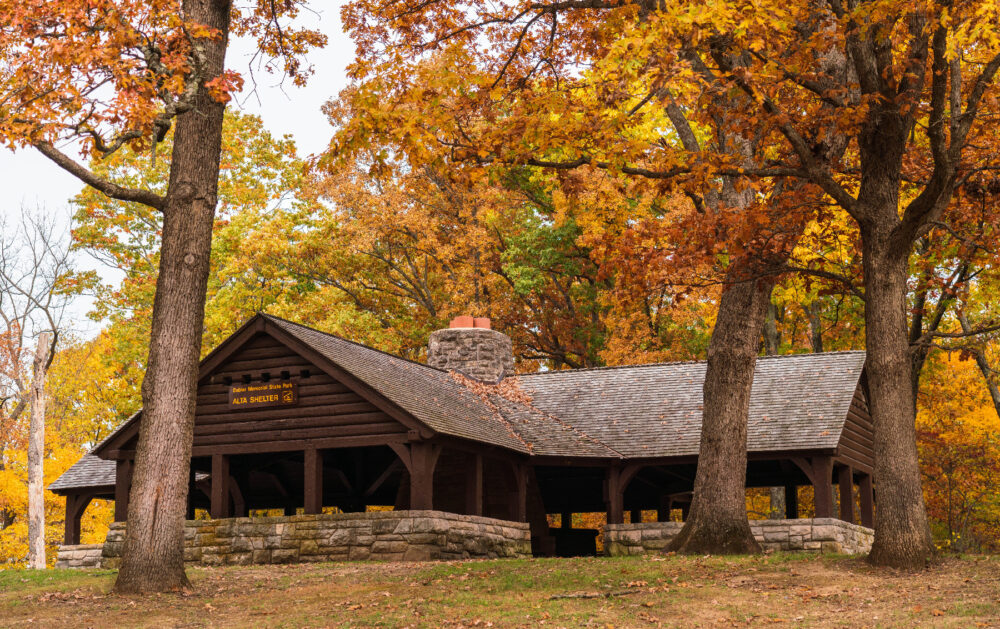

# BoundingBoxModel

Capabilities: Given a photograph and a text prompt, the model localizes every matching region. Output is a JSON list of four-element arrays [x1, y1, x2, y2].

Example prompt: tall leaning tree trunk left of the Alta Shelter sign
[[115, 0, 230, 593]]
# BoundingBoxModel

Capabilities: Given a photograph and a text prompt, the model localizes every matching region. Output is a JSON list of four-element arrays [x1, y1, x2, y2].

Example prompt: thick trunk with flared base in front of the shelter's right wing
[[668, 262, 773, 554]]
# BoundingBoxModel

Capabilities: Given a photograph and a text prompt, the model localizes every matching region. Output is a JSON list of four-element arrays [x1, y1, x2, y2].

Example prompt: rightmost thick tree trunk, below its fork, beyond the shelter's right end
[[862, 237, 934, 568]]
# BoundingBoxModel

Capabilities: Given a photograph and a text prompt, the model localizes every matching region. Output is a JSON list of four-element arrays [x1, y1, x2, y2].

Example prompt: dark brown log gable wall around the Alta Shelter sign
[[194, 334, 407, 456]]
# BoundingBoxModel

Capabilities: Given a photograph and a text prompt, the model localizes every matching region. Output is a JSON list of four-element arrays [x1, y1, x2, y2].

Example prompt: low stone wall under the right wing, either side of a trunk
[[604, 518, 874, 555]]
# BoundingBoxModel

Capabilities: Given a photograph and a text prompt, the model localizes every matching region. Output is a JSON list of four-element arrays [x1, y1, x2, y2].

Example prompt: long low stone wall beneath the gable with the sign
[[94, 511, 531, 568]]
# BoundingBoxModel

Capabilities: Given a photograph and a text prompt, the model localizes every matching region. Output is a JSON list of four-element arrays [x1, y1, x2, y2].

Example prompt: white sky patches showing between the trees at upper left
[[0, 0, 354, 334]]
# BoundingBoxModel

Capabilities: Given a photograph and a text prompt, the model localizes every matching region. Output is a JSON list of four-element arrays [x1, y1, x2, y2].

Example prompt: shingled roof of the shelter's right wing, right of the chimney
[[519, 352, 865, 458]]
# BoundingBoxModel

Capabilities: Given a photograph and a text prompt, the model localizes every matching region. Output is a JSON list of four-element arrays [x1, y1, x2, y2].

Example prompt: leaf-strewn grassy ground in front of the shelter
[[0, 554, 1000, 628]]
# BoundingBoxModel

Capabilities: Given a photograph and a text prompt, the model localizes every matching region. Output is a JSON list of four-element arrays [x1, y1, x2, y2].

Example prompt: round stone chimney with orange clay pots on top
[[427, 317, 514, 383]]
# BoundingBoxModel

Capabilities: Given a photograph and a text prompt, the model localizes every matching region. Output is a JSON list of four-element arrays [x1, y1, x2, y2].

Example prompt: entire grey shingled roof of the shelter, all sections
[[50, 315, 865, 491]]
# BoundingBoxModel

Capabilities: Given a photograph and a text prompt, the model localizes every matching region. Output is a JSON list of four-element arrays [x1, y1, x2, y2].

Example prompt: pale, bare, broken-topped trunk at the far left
[[28, 332, 51, 570]]
